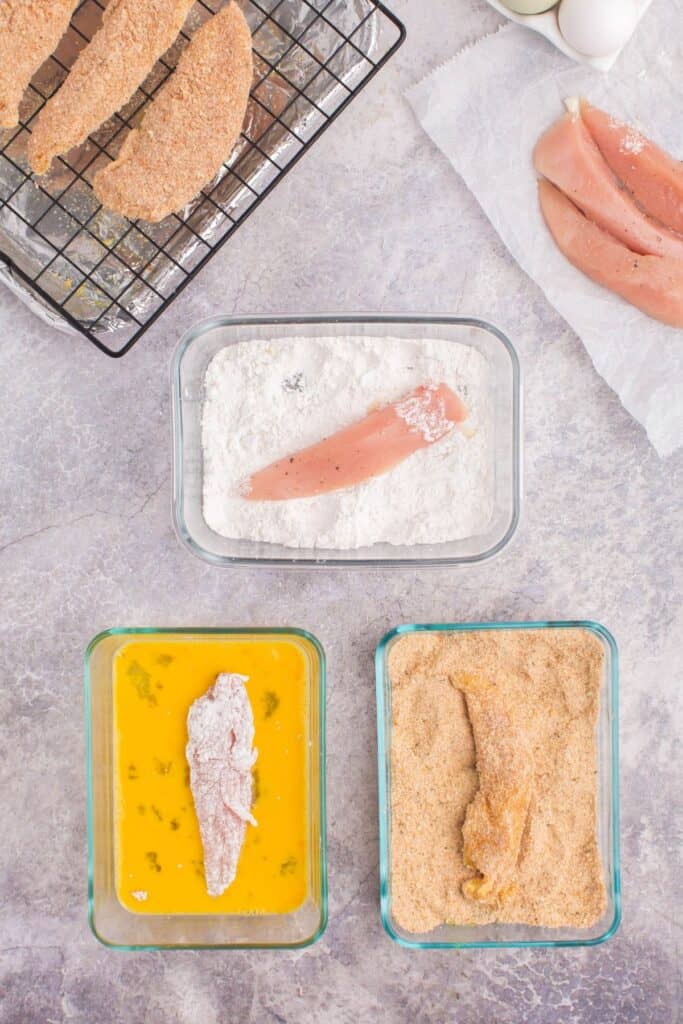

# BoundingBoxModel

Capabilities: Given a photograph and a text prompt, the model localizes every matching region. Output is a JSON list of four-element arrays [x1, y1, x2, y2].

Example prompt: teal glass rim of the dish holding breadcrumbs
[[375, 620, 622, 949]]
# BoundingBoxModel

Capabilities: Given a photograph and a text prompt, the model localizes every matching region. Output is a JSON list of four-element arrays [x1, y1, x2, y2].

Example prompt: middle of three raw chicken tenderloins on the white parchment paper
[[533, 104, 683, 260]]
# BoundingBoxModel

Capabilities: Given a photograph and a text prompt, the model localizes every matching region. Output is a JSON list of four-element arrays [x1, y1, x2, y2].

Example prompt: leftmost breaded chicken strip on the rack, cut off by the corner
[[0, 0, 78, 128]]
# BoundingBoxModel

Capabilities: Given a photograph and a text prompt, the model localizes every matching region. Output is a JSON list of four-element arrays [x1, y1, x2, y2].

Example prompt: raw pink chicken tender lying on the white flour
[[245, 384, 467, 502]]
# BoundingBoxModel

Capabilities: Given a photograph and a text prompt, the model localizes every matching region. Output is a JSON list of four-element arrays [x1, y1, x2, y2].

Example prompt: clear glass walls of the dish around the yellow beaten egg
[[85, 628, 328, 949]]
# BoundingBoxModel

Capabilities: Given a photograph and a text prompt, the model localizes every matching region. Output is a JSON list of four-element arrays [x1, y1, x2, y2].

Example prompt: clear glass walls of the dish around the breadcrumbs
[[375, 622, 622, 949]]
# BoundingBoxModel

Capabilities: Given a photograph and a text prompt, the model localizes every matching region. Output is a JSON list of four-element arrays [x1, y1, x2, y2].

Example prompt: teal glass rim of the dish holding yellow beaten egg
[[84, 626, 329, 952]]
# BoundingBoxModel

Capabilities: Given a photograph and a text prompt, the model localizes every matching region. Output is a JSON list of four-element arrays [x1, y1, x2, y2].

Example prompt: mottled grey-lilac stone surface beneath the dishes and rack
[[0, 0, 683, 1024]]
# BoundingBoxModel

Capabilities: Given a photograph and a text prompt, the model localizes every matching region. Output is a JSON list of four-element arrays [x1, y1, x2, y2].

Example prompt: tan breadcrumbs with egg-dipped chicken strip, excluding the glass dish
[[389, 629, 606, 933]]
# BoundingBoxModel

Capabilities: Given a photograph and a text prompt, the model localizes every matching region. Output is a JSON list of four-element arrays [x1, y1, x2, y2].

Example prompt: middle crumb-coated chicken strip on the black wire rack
[[29, 0, 194, 174]]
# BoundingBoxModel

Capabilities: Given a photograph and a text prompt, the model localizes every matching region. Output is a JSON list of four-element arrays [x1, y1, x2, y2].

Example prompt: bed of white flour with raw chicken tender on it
[[202, 337, 496, 550]]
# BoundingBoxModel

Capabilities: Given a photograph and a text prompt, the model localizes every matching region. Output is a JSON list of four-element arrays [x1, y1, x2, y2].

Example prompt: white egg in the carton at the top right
[[558, 0, 639, 57]]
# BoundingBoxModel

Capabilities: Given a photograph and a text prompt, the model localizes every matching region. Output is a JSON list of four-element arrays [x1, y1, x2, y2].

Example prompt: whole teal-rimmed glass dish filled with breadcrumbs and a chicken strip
[[376, 622, 621, 949]]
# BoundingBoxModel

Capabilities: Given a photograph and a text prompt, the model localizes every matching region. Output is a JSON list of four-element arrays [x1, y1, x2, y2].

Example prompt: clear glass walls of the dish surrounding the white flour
[[171, 314, 521, 567]]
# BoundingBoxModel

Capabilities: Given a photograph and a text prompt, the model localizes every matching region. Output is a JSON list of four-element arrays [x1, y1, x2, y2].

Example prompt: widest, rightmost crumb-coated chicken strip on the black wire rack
[[93, 0, 253, 221]]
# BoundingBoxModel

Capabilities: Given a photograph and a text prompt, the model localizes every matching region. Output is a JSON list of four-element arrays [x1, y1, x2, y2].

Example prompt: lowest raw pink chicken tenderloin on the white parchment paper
[[539, 181, 683, 328]]
